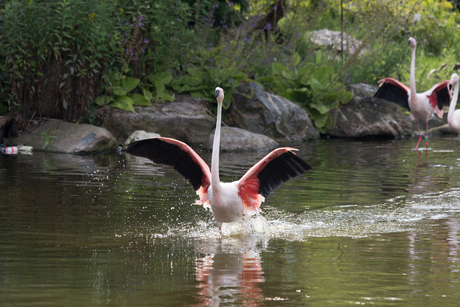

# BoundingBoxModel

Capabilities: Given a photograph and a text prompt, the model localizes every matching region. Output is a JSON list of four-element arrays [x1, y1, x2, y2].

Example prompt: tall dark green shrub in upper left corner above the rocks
[[0, 0, 117, 135]]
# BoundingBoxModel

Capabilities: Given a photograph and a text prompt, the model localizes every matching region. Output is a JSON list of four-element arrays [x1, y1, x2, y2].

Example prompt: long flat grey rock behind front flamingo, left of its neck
[[102, 100, 216, 144]]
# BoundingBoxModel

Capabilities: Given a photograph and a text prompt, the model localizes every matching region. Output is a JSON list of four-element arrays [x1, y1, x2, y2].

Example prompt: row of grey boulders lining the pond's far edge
[[0, 83, 449, 153]]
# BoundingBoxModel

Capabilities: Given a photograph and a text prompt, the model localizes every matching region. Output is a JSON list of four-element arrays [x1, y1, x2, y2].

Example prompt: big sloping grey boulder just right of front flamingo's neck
[[227, 83, 319, 141]]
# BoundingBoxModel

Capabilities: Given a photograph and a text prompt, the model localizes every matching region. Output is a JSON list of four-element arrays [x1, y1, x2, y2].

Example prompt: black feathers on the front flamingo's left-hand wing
[[125, 138, 203, 191]]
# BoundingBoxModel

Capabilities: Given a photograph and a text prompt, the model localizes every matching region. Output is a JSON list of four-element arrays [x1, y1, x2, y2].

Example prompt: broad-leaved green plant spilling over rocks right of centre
[[260, 51, 353, 132]]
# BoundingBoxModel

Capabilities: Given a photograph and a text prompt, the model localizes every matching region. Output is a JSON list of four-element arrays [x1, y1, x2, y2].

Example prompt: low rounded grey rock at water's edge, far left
[[5, 119, 118, 153]]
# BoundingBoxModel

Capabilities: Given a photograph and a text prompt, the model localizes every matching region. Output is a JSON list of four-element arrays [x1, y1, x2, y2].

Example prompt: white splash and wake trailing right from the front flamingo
[[126, 190, 460, 241]]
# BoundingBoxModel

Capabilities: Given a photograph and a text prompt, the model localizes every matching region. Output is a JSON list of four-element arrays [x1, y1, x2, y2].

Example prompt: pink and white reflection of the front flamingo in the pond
[[196, 237, 265, 306]]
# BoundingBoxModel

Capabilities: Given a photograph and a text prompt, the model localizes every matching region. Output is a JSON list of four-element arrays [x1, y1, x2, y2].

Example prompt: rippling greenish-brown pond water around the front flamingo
[[0, 136, 460, 306]]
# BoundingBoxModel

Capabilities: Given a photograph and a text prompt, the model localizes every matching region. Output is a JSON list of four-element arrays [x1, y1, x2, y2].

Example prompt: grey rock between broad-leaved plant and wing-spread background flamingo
[[326, 84, 412, 138]]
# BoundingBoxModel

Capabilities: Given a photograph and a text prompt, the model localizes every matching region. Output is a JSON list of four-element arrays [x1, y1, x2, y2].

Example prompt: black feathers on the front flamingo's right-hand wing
[[257, 151, 312, 197]]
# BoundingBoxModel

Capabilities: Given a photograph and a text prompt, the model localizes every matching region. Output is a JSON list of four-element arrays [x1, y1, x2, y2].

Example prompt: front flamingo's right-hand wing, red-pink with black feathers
[[238, 147, 311, 211]]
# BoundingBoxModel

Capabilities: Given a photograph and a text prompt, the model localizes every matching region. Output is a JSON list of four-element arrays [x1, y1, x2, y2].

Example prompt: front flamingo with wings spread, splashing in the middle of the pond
[[126, 87, 311, 234]]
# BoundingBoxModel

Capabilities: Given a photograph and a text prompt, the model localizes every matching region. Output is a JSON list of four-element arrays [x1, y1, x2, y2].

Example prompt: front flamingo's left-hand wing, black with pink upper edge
[[125, 137, 211, 204]]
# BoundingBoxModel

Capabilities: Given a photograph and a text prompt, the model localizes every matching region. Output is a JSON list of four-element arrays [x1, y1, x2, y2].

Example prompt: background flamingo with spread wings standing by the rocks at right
[[374, 37, 450, 150]]
